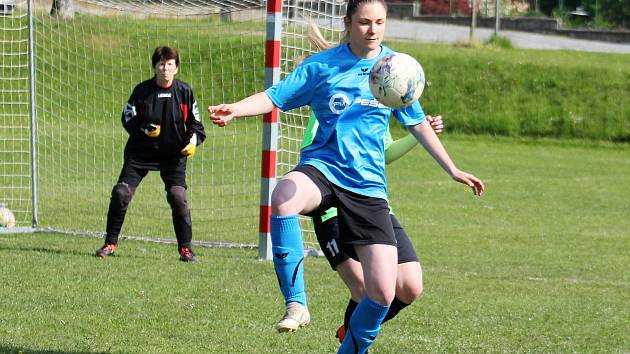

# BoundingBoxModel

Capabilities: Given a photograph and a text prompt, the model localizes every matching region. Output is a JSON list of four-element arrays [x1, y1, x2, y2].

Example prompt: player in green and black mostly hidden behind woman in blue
[[302, 112, 444, 342]]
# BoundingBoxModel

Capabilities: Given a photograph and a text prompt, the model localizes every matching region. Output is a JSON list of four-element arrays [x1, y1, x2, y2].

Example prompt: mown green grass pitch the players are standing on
[[0, 135, 630, 353]]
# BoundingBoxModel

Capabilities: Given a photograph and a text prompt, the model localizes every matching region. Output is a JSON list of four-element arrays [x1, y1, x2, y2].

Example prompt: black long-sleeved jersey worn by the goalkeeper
[[121, 79, 206, 170]]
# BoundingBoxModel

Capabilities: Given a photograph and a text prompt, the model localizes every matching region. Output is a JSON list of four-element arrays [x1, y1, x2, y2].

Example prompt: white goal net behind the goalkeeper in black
[[0, 0, 345, 254]]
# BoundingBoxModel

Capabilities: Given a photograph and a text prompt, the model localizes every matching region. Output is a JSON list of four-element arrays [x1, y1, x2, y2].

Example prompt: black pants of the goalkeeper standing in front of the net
[[105, 161, 192, 248]]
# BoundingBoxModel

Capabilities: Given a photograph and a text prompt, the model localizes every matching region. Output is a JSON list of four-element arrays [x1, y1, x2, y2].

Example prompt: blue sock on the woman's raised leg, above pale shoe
[[271, 215, 306, 305]]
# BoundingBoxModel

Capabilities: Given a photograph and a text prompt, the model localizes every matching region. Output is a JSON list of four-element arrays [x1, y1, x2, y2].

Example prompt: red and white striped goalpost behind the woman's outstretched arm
[[258, 0, 282, 260]]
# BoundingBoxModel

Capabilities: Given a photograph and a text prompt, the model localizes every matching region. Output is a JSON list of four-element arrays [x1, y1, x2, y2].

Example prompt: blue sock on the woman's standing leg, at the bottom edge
[[337, 295, 389, 354]]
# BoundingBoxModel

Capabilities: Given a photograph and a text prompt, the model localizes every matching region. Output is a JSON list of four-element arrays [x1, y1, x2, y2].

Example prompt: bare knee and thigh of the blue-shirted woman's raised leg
[[271, 171, 322, 215]]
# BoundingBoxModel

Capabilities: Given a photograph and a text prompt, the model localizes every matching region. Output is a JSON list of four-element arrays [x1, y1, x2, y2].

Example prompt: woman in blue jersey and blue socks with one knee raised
[[208, 0, 484, 353]]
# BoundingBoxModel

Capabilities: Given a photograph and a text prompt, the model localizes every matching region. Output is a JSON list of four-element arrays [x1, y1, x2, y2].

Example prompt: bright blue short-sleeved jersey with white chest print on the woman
[[265, 44, 424, 200]]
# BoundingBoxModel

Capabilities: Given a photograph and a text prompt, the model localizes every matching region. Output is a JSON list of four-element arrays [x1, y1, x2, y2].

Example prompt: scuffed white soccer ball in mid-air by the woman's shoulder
[[370, 53, 425, 108]]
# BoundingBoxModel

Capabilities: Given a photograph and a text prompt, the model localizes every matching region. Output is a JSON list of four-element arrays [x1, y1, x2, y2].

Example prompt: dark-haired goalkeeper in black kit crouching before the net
[[96, 47, 206, 262]]
